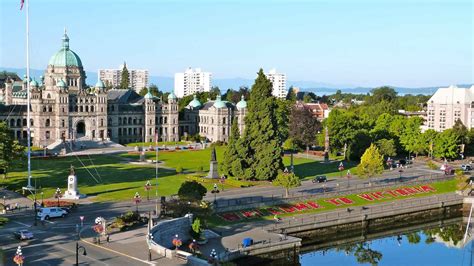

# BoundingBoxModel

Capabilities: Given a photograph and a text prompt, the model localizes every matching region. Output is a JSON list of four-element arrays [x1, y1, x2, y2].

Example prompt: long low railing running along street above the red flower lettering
[[214, 174, 454, 212]]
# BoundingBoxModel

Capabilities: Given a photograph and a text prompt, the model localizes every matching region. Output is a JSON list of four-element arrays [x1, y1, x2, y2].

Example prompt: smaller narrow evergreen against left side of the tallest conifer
[[220, 119, 242, 178]]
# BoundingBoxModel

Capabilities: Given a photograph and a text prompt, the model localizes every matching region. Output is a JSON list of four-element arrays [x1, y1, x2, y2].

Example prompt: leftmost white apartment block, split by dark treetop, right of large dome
[[98, 63, 148, 92]]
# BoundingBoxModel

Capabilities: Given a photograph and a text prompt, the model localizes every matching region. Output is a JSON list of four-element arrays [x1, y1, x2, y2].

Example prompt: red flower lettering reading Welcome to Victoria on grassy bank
[[218, 185, 436, 222]]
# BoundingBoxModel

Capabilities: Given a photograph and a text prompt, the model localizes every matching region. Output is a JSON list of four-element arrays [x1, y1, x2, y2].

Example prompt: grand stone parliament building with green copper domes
[[0, 33, 246, 147]]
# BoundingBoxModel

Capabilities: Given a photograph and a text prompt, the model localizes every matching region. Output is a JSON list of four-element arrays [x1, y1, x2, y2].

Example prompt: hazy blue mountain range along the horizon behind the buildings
[[0, 67, 473, 95]]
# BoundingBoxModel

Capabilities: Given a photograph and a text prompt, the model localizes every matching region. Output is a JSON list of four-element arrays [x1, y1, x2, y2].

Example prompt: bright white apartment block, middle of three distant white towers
[[174, 68, 212, 98]]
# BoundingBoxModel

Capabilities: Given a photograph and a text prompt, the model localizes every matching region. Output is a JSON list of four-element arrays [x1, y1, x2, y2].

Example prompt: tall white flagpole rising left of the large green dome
[[26, 0, 31, 189]]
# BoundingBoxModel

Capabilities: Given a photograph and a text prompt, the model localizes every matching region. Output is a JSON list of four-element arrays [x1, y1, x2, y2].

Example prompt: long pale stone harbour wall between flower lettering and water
[[262, 194, 463, 231]]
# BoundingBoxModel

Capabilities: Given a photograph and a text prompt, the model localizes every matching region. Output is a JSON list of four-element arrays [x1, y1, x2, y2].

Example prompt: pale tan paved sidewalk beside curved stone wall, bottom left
[[81, 225, 186, 266]]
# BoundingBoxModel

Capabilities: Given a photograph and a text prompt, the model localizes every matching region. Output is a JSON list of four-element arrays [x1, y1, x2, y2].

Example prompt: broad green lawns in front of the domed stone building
[[0, 146, 360, 201]]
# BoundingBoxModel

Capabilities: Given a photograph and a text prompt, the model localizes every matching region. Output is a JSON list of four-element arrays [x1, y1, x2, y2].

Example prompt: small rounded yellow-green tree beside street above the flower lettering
[[357, 144, 383, 182]]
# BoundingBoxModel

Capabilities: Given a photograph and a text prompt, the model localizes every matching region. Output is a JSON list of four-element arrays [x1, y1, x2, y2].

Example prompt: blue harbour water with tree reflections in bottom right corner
[[300, 222, 474, 266]]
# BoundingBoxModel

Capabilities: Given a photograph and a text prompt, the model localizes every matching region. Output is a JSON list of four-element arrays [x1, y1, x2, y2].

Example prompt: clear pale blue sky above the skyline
[[0, 0, 474, 87]]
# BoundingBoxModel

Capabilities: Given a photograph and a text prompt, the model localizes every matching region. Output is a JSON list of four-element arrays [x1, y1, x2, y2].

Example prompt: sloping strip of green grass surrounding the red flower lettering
[[207, 180, 456, 226]]
